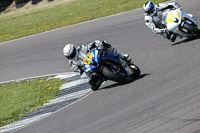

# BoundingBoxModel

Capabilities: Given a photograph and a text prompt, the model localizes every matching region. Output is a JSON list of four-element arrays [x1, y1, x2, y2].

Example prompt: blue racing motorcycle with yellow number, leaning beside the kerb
[[80, 48, 140, 90]]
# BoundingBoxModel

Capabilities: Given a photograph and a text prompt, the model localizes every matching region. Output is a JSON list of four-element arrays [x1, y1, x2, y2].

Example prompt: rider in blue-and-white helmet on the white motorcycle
[[143, 1, 184, 42]]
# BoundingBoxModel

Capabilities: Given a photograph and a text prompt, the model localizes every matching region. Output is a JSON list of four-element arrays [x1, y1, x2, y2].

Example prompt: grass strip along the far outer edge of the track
[[0, 0, 166, 42]]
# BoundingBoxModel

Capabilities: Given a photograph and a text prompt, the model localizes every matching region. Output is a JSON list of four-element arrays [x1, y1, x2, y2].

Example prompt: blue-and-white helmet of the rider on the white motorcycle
[[143, 1, 156, 16]]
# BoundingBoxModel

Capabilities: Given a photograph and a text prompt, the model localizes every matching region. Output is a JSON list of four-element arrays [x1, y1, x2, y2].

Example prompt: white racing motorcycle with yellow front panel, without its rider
[[165, 5, 200, 38]]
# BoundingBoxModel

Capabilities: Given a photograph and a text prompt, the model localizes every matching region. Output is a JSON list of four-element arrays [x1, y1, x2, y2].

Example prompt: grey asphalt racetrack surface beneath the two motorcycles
[[0, 0, 200, 133]]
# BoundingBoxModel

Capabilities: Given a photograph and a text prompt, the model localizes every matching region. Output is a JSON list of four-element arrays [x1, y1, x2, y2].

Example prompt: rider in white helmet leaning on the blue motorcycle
[[63, 40, 131, 90]]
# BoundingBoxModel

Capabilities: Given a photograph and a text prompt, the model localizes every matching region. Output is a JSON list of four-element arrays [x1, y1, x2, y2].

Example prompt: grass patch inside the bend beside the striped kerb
[[0, 78, 63, 127]]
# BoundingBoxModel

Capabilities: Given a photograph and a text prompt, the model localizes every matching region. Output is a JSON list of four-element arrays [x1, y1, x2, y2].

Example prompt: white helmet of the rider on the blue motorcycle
[[63, 44, 77, 60]]
